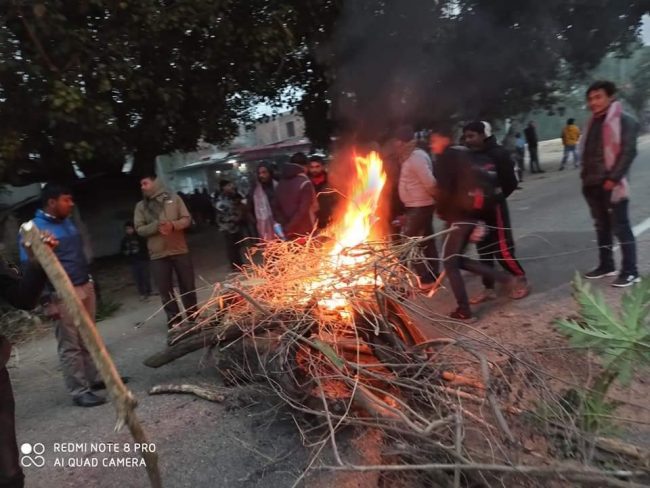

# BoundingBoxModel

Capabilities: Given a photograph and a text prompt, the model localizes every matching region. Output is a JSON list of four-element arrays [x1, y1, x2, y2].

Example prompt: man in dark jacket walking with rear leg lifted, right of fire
[[431, 131, 523, 320]]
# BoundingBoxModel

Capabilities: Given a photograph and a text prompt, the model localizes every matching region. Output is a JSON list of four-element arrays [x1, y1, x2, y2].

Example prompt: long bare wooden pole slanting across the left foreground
[[20, 221, 162, 488]]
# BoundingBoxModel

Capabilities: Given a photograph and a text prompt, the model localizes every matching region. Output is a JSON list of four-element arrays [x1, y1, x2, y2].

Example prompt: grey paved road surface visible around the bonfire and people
[[11, 135, 650, 488]]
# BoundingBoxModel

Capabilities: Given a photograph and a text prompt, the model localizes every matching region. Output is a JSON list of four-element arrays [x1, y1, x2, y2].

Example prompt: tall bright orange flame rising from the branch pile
[[308, 151, 386, 318]]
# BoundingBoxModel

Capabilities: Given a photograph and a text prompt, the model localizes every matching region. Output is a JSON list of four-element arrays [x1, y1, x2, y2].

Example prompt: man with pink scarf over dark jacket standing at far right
[[580, 81, 641, 288]]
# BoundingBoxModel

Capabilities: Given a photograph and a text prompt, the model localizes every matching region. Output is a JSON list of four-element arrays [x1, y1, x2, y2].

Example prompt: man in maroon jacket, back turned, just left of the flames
[[275, 153, 318, 240]]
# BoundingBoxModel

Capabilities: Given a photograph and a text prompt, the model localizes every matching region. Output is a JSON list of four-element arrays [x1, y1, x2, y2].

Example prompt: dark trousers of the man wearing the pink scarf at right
[[582, 186, 638, 275]]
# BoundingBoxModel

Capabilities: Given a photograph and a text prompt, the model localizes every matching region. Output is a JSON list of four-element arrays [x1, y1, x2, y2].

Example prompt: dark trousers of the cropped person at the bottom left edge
[[0, 366, 24, 488]]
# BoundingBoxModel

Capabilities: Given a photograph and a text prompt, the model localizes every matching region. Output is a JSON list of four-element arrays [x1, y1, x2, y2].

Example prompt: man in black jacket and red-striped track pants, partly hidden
[[463, 122, 530, 304]]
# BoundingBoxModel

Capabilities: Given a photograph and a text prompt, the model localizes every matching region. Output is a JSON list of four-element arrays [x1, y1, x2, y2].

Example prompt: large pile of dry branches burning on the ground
[[147, 234, 649, 487]]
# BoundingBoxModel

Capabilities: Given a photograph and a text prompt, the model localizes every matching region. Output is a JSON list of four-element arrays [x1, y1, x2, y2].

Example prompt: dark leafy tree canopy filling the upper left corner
[[0, 0, 293, 183]]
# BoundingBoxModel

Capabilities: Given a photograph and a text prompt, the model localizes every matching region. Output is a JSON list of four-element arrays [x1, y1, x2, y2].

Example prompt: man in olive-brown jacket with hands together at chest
[[133, 175, 196, 329]]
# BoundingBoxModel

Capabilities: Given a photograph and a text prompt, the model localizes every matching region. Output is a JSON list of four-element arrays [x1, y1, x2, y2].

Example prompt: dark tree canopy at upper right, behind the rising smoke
[[294, 0, 648, 145]]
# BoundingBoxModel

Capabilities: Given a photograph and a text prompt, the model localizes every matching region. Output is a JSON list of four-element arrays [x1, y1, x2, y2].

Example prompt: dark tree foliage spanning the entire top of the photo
[[0, 0, 649, 183]]
